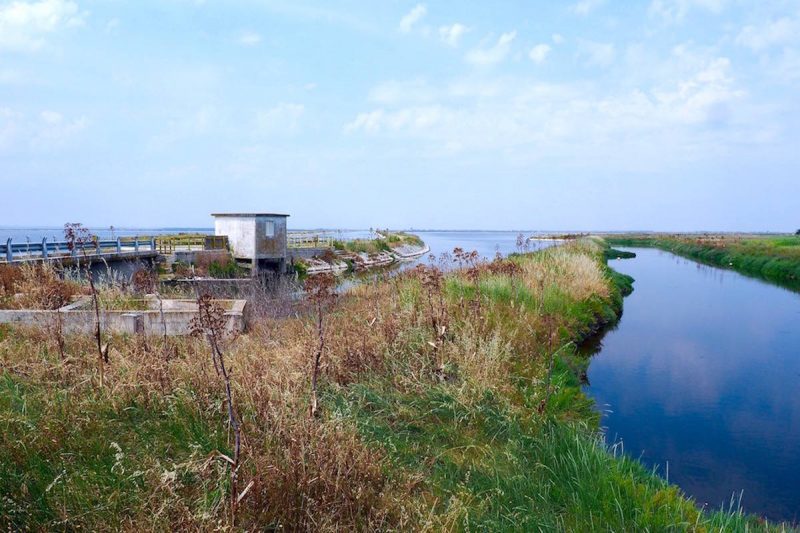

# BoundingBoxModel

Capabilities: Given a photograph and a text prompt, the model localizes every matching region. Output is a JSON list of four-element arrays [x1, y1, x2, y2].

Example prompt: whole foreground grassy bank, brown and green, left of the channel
[[0, 240, 780, 531]]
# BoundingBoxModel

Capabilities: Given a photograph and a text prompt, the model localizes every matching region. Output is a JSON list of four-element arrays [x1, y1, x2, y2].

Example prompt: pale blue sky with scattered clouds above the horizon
[[0, 0, 800, 231]]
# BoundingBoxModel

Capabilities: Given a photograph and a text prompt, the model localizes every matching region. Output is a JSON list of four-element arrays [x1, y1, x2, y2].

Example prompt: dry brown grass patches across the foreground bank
[[0, 240, 620, 531]]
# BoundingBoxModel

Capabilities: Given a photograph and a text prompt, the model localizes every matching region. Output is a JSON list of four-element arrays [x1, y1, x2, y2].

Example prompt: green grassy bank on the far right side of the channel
[[607, 235, 800, 290]]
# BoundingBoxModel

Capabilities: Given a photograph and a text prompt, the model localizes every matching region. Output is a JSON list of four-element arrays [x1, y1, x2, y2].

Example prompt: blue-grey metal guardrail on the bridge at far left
[[0, 237, 156, 263]]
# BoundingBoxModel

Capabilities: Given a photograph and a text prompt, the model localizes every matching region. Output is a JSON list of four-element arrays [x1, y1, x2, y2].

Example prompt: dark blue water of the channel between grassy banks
[[587, 249, 800, 522]]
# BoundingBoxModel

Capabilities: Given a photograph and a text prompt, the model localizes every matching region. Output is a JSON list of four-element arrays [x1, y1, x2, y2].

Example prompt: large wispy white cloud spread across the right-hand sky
[[344, 48, 752, 164]]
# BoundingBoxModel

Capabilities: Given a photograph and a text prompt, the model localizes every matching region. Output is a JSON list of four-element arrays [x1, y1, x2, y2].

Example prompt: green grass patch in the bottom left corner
[[0, 374, 227, 530]]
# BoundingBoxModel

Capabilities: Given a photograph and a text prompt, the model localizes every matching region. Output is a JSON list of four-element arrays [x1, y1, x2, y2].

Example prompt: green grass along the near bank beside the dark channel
[[330, 251, 761, 531]]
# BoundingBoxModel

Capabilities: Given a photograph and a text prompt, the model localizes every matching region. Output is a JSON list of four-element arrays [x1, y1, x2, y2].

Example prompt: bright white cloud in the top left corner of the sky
[[0, 0, 86, 51]]
